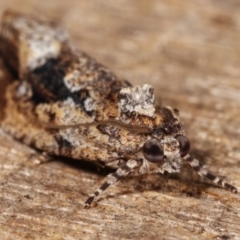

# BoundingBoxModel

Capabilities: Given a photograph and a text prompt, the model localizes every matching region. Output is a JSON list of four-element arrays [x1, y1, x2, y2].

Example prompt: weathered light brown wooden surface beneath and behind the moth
[[0, 0, 240, 240]]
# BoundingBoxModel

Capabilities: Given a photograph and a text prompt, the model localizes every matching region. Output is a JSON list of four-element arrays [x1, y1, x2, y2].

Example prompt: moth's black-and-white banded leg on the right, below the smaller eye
[[184, 154, 238, 193]]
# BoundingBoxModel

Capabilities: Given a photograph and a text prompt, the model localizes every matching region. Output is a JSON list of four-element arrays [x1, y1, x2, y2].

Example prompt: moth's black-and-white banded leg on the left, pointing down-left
[[85, 160, 140, 208]]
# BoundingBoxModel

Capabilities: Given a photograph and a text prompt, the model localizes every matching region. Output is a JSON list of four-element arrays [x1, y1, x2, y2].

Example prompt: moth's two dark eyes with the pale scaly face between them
[[142, 134, 190, 164]]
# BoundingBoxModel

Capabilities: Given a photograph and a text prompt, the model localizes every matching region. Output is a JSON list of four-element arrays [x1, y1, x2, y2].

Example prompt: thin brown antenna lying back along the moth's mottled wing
[[39, 119, 152, 134]]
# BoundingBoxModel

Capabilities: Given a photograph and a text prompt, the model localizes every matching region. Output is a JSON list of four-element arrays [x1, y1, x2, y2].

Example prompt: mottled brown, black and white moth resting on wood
[[0, 11, 237, 207]]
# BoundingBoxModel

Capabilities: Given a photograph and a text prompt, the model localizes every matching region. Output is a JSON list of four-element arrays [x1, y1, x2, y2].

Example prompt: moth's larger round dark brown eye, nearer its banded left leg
[[143, 139, 164, 163]]
